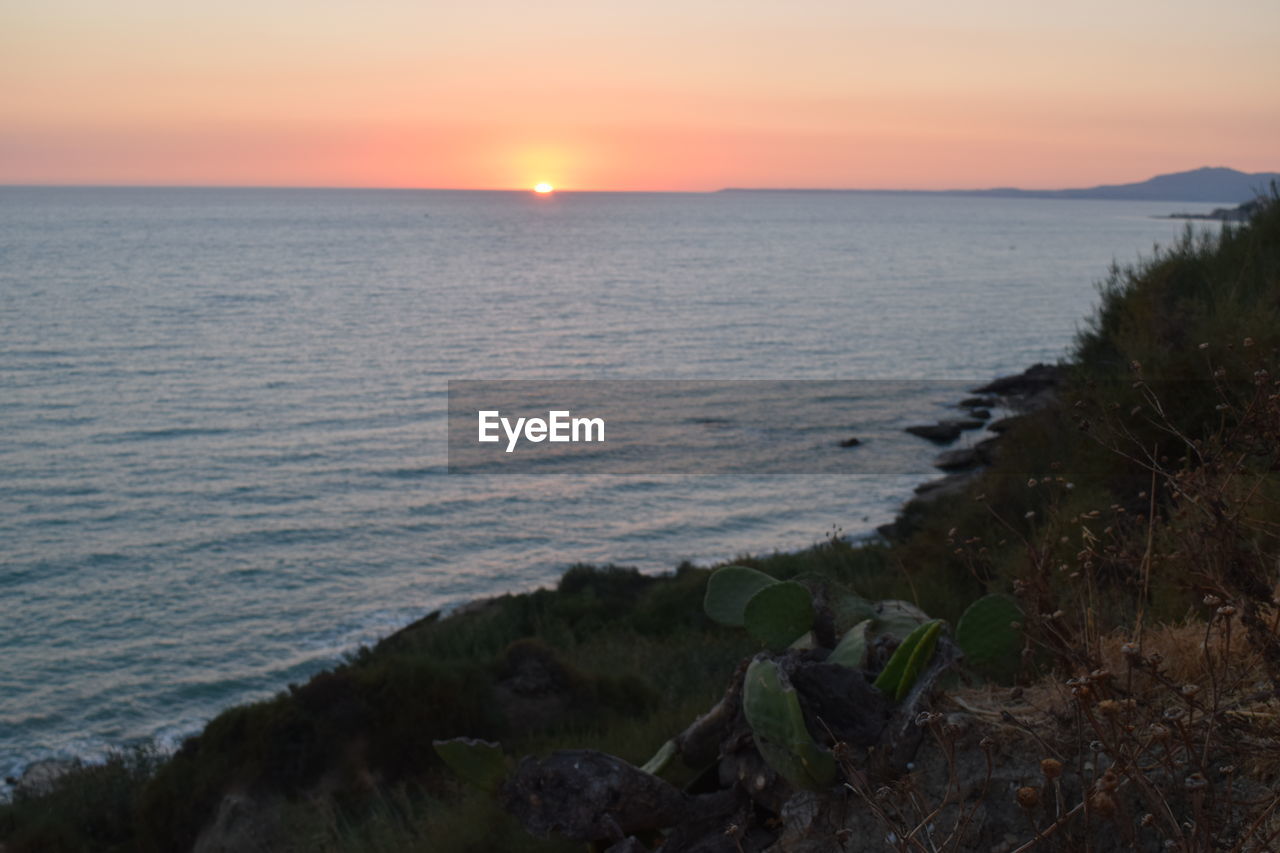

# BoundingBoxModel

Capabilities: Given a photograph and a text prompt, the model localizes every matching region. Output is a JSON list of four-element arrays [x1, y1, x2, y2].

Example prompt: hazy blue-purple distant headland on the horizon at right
[[721, 167, 1280, 202]]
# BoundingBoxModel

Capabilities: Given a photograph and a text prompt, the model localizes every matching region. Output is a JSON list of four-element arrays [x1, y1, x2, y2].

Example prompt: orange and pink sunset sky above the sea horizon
[[0, 0, 1280, 191]]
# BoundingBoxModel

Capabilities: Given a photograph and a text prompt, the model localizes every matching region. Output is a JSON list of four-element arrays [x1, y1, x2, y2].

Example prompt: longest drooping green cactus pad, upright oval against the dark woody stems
[[742, 657, 836, 790]]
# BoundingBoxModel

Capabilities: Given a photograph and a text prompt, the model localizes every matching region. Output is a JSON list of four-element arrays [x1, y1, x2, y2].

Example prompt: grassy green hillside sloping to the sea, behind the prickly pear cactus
[[0, 194, 1280, 853]]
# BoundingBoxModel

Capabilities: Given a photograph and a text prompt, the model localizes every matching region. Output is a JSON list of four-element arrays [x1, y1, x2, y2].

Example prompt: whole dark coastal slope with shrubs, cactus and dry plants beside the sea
[[0, 197, 1280, 853]]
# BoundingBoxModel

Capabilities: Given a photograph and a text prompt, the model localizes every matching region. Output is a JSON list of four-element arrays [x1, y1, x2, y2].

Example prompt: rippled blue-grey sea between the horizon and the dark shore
[[0, 188, 1208, 775]]
